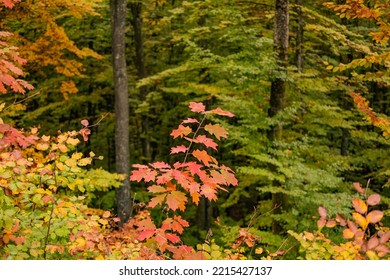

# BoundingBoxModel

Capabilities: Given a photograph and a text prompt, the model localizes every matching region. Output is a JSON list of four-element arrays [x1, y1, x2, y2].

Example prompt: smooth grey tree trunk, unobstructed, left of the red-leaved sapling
[[111, 0, 131, 226]]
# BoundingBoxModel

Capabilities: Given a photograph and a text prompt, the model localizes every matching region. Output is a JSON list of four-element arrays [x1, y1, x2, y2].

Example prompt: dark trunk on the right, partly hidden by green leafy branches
[[268, 0, 289, 234]]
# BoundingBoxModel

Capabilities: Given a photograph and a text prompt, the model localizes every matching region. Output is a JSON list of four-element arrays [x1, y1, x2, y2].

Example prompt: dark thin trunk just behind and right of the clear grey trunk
[[130, 2, 152, 162]]
